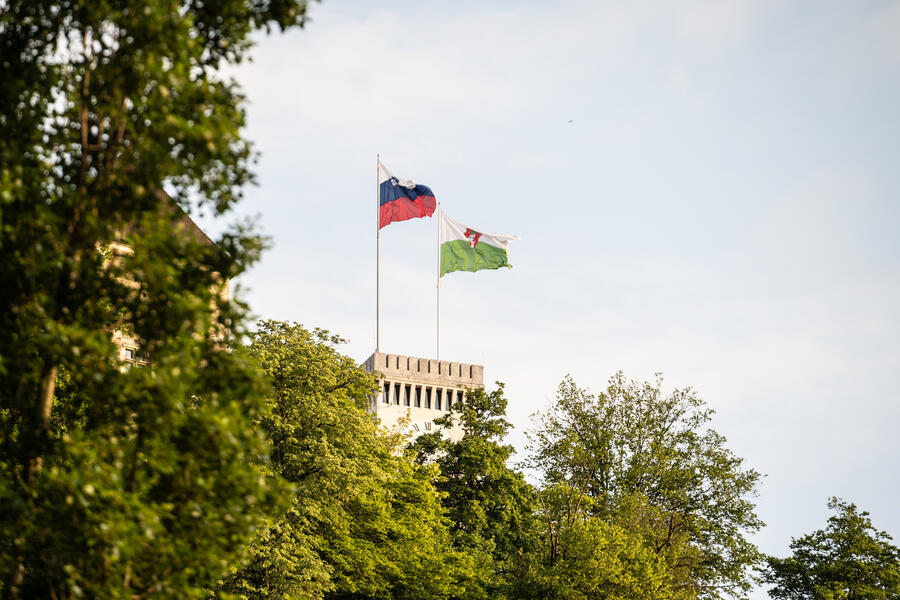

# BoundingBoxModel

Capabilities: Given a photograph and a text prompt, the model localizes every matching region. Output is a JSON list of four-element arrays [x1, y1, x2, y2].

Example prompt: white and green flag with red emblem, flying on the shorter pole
[[441, 212, 519, 277]]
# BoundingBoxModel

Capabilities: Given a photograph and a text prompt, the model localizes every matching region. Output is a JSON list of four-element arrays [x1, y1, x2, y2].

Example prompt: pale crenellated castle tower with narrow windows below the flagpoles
[[363, 352, 484, 441]]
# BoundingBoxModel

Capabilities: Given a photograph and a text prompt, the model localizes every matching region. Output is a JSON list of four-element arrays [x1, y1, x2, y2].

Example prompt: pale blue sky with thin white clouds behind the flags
[[197, 0, 900, 598]]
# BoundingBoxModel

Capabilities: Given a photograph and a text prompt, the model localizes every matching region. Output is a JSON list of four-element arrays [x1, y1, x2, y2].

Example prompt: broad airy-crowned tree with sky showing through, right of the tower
[[526, 372, 762, 598]]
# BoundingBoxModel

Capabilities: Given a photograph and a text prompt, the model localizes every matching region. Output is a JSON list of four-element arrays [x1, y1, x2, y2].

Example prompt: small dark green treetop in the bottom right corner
[[764, 498, 900, 600]]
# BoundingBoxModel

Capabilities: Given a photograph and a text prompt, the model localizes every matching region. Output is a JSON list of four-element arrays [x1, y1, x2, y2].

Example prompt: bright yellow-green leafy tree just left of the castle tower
[[222, 321, 492, 599]]
